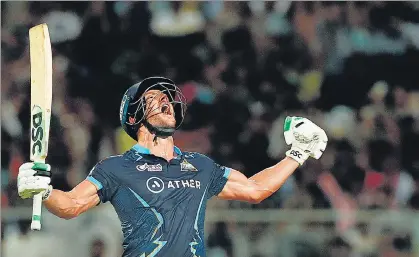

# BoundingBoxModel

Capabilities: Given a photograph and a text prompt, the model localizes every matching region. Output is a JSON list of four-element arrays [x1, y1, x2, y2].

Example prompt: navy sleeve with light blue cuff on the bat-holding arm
[[86, 163, 117, 203]]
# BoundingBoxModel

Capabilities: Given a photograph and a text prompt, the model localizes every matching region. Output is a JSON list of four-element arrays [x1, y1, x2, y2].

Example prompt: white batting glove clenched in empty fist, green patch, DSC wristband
[[284, 116, 328, 165]]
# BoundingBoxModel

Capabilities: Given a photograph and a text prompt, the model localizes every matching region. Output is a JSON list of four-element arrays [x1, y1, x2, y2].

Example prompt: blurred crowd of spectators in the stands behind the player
[[1, 1, 419, 257]]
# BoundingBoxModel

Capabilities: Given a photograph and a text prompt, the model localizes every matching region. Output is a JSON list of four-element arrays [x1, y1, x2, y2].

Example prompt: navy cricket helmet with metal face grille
[[119, 77, 187, 140]]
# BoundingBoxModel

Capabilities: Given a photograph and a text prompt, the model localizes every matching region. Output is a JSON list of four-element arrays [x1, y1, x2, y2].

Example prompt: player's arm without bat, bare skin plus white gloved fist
[[218, 117, 327, 203]]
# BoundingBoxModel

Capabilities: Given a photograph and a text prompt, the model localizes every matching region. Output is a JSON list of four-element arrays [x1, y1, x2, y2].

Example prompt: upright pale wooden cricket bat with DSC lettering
[[29, 24, 52, 230]]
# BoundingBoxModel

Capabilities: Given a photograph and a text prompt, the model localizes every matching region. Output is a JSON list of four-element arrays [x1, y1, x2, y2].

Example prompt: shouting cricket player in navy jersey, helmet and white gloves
[[17, 77, 327, 257]]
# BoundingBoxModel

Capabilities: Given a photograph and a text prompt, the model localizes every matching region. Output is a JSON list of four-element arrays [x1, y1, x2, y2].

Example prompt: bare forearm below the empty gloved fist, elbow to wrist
[[249, 157, 299, 201]]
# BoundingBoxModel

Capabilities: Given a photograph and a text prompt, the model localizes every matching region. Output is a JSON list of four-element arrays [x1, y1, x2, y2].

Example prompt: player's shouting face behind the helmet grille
[[144, 90, 176, 128]]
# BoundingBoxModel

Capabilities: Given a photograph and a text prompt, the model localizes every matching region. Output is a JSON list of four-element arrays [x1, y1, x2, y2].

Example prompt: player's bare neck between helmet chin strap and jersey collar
[[138, 126, 175, 161]]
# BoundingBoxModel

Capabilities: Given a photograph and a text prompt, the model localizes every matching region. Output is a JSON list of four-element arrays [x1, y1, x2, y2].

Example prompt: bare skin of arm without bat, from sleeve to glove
[[218, 157, 299, 203]]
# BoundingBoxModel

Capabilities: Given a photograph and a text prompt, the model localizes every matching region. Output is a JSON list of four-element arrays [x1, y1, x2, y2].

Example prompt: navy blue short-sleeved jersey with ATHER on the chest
[[87, 145, 230, 257]]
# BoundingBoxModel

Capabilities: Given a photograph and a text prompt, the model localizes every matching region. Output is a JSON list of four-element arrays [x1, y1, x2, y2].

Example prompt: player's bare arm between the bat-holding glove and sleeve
[[43, 180, 100, 219]]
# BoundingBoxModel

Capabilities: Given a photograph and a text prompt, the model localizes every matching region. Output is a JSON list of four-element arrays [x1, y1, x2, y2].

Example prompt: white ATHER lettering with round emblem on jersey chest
[[146, 177, 201, 194]]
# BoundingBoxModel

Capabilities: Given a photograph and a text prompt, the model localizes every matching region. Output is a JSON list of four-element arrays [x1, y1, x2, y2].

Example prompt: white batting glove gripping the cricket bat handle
[[17, 162, 52, 200]]
